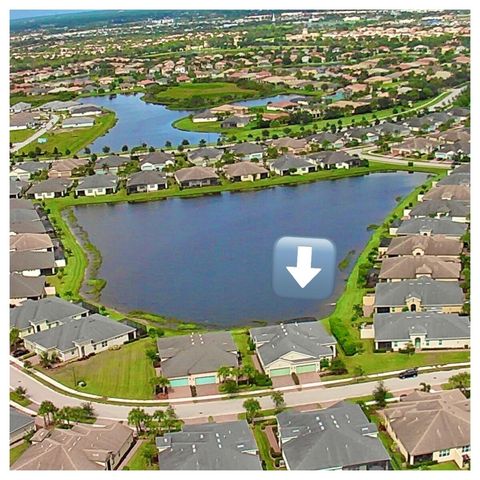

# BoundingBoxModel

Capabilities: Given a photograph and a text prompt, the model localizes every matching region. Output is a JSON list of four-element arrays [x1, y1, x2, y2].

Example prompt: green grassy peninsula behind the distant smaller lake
[[143, 82, 262, 109]]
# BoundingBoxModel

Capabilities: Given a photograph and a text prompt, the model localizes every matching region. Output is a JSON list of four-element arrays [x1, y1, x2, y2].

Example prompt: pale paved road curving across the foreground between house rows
[[10, 366, 469, 420]]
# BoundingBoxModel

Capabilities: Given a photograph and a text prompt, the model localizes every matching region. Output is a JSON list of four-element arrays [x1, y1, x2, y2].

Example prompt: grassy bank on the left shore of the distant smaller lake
[[19, 112, 116, 159]]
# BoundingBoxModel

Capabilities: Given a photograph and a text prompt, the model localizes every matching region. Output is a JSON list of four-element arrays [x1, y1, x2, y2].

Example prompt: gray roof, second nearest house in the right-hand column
[[375, 277, 464, 307]]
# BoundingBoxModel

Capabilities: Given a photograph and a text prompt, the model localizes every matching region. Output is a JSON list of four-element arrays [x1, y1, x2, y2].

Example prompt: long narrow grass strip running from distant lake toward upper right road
[[173, 92, 448, 141]]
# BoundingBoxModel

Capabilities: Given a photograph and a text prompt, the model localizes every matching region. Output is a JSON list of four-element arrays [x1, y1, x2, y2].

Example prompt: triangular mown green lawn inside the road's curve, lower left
[[42, 338, 155, 400]]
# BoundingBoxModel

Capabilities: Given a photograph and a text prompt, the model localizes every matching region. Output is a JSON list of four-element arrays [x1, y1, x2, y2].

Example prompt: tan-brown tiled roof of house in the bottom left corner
[[11, 422, 134, 471]]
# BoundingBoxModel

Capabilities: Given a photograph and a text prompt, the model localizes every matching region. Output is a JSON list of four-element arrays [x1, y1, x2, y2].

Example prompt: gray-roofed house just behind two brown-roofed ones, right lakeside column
[[390, 217, 468, 239]]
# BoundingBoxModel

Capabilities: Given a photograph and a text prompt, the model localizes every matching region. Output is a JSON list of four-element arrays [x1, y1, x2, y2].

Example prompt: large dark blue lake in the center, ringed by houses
[[75, 172, 427, 326]]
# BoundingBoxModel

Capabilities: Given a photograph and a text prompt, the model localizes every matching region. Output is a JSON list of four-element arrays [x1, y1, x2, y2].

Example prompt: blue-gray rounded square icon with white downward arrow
[[273, 237, 337, 299]]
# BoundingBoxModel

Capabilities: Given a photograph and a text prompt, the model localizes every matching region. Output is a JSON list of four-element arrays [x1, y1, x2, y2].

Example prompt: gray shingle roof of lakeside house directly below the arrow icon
[[250, 321, 336, 366]]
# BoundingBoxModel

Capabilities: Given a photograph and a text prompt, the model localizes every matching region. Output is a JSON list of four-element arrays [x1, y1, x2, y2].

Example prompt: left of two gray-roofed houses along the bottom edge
[[155, 420, 262, 471]]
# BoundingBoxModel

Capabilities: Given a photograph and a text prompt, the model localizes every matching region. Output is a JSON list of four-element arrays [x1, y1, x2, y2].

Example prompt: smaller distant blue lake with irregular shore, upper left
[[82, 94, 298, 153]]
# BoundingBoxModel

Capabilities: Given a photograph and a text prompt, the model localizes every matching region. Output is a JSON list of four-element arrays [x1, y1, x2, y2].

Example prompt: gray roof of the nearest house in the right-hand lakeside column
[[373, 312, 470, 342]]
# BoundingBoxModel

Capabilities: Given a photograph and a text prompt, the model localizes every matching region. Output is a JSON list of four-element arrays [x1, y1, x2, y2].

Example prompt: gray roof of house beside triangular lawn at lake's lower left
[[25, 313, 135, 352]]
